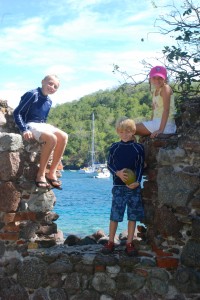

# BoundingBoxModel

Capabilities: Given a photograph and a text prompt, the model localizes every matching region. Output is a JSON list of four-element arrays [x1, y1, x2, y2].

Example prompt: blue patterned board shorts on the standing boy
[[110, 186, 144, 222]]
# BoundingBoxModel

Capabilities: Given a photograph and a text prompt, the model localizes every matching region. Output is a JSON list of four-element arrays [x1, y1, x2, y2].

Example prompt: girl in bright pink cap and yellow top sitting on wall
[[136, 66, 176, 138]]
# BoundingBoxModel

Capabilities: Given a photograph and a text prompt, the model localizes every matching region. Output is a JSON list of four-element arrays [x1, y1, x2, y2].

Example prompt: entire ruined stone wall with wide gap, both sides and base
[[0, 99, 200, 300]]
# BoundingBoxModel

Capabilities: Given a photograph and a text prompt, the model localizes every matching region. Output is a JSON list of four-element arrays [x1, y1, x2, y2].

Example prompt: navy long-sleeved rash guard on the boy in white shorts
[[13, 87, 52, 132]]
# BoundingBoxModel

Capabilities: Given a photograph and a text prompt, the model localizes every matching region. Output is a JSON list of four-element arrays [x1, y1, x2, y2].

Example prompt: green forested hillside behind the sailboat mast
[[48, 83, 151, 168]]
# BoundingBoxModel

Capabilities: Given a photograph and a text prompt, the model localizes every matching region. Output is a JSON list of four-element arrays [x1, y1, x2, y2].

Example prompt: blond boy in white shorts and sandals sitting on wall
[[13, 75, 68, 189]]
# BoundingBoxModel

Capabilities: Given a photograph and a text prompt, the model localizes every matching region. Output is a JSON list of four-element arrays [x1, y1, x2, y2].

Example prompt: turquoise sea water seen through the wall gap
[[53, 171, 139, 237]]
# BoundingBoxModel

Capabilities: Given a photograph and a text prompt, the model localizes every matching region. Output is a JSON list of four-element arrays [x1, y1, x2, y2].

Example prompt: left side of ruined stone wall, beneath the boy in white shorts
[[0, 100, 63, 246]]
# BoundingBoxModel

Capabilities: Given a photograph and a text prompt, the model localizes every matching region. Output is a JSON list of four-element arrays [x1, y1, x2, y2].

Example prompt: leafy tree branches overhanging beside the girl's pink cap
[[154, 0, 200, 97]]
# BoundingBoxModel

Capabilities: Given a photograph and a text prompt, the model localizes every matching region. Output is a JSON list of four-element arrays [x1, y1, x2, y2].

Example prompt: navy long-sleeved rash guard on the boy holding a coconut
[[107, 141, 144, 185]]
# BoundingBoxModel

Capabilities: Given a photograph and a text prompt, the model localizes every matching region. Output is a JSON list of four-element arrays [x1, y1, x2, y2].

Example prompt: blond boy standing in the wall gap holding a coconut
[[102, 117, 144, 256]]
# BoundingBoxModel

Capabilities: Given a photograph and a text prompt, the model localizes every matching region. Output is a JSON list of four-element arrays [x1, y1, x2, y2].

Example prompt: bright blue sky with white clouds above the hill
[[0, 0, 182, 108]]
